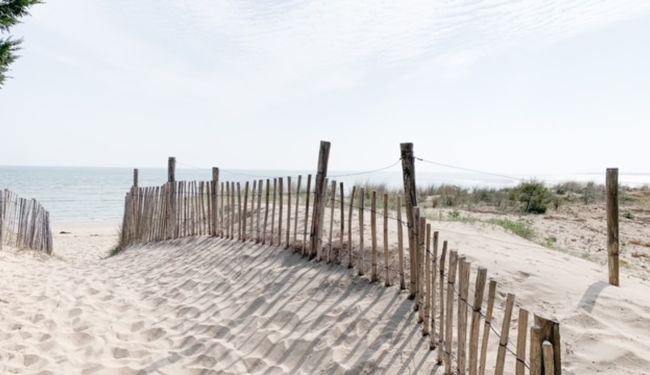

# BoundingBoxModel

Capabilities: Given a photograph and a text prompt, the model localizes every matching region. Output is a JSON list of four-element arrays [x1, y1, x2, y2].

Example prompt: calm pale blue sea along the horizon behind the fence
[[0, 167, 650, 223]]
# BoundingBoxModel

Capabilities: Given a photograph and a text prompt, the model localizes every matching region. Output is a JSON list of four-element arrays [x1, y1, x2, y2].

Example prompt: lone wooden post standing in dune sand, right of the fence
[[607, 168, 620, 286]]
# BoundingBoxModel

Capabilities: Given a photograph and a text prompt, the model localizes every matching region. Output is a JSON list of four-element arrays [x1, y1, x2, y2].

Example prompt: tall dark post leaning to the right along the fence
[[309, 141, 330, 258]]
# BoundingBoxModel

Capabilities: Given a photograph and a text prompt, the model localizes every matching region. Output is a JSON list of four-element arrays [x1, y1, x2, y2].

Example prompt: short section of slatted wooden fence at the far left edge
[[0, 189, 52, 254]]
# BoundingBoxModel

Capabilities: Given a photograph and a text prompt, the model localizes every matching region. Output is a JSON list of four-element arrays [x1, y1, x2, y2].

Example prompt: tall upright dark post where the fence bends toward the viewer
[[400, 143, 418, 299]]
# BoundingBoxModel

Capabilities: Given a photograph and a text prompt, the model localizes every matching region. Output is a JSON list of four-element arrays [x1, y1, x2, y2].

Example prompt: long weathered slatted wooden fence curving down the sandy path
[[122, 146, 562, 375]]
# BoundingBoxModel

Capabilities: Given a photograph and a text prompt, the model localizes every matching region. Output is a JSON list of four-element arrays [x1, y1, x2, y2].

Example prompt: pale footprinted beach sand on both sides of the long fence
[[0, 222, 650, 374]]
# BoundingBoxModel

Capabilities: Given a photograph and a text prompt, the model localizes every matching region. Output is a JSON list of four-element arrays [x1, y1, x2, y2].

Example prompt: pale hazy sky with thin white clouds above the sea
[[0, 0, 650, 174]]
